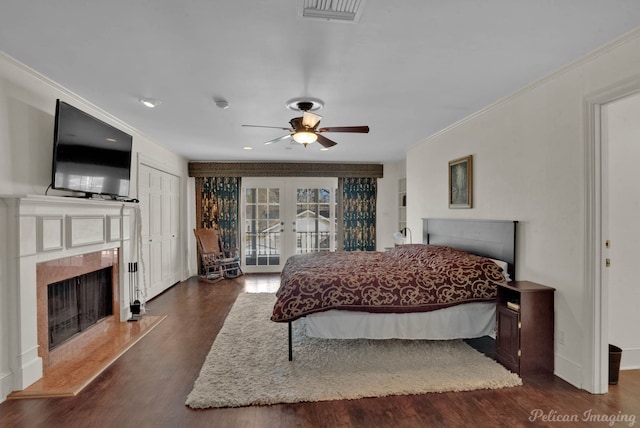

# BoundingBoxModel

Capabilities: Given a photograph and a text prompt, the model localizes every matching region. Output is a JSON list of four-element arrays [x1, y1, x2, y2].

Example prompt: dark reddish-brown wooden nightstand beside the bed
[[496, 281, 555, 375]]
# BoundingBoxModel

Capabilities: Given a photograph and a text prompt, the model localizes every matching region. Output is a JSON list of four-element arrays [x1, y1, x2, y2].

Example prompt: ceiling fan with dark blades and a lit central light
[[242, 101, 369, 149]]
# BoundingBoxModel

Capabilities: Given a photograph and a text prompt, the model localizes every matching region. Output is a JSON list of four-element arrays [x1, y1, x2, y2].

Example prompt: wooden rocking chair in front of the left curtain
[[193, 229, 243, 282]]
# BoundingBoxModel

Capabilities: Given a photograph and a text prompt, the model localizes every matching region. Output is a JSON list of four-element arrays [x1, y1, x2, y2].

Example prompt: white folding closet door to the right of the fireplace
[[138, 164, 180, 299]]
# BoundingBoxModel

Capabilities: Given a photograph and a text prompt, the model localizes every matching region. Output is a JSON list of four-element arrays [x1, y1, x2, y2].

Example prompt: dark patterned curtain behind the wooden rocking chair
[[196, 177, 240, 248]]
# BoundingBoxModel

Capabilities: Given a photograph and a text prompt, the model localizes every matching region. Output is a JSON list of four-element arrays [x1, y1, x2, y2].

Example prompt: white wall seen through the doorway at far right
[[604, 95, 640, 369]]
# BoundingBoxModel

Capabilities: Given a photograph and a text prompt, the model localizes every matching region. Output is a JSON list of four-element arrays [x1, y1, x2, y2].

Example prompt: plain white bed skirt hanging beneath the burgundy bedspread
[[294, 302, 496, 340]]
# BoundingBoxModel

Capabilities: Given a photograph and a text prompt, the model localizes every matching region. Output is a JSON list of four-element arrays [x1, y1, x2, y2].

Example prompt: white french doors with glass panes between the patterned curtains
[[241, 178, 338, 272]]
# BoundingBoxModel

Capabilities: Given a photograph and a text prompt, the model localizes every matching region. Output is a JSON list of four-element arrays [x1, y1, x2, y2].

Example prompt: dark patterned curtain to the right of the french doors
[[339, 178, 378, 251]]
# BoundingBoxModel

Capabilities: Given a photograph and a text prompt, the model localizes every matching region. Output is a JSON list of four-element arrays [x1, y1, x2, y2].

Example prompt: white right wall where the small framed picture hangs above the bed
[[407, 31, 640, 387]]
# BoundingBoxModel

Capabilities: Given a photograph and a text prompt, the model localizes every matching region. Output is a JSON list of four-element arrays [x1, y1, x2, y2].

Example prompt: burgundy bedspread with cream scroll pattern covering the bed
[[271, 244, 505, 322]]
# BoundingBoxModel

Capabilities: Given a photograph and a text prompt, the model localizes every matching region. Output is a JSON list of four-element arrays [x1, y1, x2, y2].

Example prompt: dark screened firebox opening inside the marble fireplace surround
[[47, 267, 113, 350]]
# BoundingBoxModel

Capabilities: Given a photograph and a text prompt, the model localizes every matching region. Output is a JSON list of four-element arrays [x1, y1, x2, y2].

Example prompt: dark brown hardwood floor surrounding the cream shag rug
[[0, 275, 640, 428]]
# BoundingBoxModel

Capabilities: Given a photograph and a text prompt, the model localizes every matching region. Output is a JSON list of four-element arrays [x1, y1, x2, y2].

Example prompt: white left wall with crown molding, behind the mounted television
[[0, 53, 195, 401]]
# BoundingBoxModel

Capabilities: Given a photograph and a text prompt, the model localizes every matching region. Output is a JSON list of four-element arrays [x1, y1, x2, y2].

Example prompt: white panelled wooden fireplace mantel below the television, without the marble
[[0, 195, 139, 390]]
